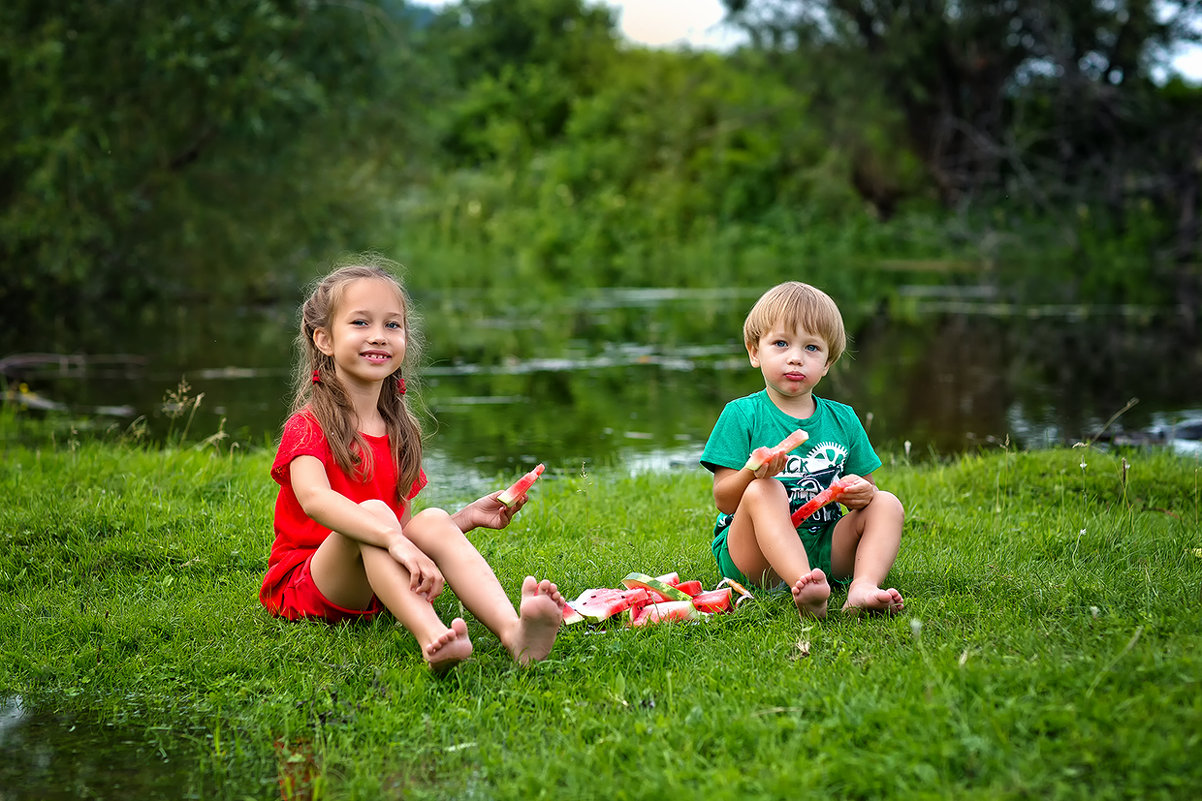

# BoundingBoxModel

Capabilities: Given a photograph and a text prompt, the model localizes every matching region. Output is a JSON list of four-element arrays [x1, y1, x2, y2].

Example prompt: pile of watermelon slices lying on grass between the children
[[564, 572, 751, 627]]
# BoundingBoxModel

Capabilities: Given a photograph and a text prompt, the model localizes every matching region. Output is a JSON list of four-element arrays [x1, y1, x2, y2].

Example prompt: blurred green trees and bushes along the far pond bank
[[0, 0, 1202, 350]]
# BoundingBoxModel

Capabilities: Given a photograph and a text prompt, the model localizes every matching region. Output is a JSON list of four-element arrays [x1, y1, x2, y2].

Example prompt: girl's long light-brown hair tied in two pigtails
[[292, 254, 422, 500]]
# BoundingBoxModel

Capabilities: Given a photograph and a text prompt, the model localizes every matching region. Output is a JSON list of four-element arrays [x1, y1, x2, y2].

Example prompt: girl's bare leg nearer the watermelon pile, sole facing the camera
[[405, 509, 564, 664]]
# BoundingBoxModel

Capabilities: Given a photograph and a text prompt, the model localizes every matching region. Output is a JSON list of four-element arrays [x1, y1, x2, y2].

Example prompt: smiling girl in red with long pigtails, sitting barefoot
[[260, 260, 564, 672]]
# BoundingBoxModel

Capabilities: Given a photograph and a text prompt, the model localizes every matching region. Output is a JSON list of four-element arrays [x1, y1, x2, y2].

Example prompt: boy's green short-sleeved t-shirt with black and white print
[[701, 390, 881, 532]]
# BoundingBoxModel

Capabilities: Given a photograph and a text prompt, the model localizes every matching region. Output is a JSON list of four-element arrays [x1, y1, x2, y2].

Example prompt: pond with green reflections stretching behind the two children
[[5, 287, 1202, 483]]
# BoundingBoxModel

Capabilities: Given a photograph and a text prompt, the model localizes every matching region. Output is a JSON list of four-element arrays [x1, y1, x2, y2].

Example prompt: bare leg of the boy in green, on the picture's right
[[831, 491, 905, 613]]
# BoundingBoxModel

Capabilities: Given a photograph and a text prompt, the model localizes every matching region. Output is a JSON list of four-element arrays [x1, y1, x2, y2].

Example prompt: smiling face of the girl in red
[[313, 278, 405, 388]]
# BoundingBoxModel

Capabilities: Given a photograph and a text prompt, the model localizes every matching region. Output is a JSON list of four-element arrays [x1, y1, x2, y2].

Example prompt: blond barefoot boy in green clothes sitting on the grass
[[701, 281, 905, 618]]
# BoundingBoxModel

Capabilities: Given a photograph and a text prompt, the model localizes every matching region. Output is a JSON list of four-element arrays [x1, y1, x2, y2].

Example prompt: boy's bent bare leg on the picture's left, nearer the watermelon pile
[[726, 479, 831, 618]]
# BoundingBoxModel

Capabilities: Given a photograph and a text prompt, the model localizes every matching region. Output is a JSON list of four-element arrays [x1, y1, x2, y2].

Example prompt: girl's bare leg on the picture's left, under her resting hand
[[311, 500, 471, 671]]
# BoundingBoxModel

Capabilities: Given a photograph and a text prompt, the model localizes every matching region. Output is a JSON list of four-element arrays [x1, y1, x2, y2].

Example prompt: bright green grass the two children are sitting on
[[0, 432, 1202, 800]]
